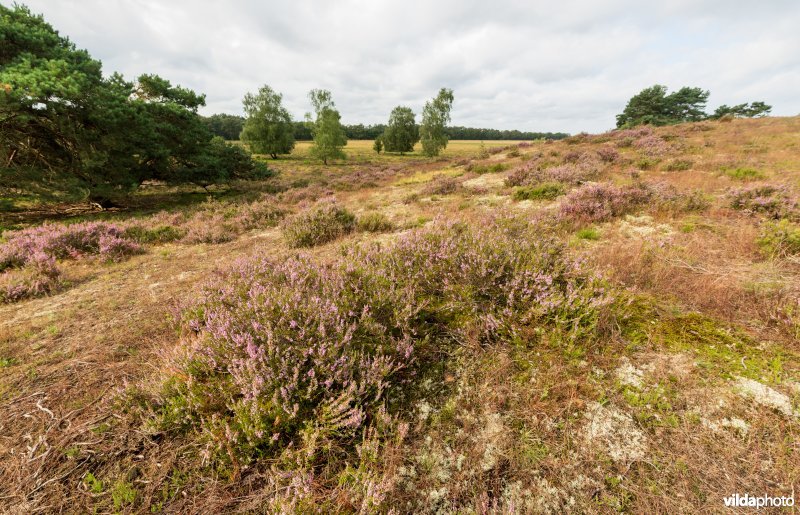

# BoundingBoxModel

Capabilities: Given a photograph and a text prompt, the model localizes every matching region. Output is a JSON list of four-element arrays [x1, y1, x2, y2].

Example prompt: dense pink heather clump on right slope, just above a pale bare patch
[[559, 183, 652, 223]]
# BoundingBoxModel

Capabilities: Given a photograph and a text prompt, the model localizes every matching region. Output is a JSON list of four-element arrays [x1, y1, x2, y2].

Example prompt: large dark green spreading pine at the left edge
[[0, 5, 267, 203]]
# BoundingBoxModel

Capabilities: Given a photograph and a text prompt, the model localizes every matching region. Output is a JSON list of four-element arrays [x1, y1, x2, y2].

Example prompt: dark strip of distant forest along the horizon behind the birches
[[203, 114, 569, 141]]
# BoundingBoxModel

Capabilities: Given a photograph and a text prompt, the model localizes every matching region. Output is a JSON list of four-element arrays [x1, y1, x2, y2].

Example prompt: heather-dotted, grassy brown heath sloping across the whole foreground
[[0, 117, 800, 513]]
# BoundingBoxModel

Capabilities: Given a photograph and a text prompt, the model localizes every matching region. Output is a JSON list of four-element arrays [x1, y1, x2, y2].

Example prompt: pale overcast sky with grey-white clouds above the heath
[[15, 0, 800, 133]]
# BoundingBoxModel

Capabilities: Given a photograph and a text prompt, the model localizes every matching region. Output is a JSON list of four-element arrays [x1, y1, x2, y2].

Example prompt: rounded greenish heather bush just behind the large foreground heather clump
[[282, 203, 356, 248]]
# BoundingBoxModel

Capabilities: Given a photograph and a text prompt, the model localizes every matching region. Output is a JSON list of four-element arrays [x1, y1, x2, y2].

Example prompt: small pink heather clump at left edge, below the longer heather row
[[0, 252, 61, 304]]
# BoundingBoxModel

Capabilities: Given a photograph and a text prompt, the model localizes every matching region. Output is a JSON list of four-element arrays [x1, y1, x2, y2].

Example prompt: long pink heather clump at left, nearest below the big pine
[[0, 222, 142, 271]]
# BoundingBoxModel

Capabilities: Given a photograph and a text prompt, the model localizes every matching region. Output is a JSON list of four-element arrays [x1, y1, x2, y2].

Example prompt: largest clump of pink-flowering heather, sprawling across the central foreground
[[157, 223, 611, 463]]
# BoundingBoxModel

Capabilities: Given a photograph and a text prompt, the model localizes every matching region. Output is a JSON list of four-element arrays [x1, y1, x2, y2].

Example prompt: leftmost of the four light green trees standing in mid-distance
[[241, 85, 294, 159]]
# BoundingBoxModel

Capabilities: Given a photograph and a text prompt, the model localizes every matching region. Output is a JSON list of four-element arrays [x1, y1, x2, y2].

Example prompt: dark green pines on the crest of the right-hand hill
[[617, 84, 772, 128]]
